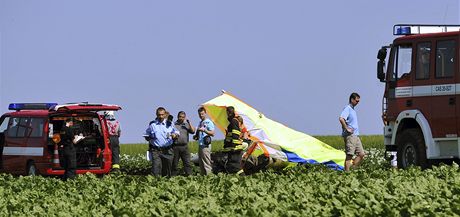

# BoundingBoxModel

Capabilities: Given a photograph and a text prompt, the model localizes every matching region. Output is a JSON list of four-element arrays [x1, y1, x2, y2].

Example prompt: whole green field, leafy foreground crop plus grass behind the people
[[0, 136, 460, 216]]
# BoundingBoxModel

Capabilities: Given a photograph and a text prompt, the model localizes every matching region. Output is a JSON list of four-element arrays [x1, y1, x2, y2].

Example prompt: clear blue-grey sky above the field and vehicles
[[0, 0, 460, 143]]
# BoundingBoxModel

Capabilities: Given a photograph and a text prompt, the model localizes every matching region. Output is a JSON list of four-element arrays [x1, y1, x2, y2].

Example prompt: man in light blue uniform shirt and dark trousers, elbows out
[[145, 107, 180, 176]]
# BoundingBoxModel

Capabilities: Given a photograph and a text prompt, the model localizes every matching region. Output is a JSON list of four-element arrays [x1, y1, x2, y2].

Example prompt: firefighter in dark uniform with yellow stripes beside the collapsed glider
[[224, 106, 243, 173]]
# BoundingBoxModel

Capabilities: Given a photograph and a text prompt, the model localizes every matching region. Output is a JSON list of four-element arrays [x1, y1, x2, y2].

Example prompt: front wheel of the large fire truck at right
[[396, 129, 427, 169]]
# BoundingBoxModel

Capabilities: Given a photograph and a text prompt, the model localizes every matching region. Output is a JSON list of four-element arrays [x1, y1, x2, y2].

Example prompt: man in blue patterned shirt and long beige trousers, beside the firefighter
[[194, 107, 214, 175]]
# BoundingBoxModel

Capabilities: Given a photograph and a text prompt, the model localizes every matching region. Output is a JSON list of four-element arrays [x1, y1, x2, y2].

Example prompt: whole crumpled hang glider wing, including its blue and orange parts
[[203, 92, 345, 170]]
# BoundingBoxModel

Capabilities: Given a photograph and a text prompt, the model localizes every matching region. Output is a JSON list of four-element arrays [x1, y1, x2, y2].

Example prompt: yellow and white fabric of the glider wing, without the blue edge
[[203, 93, 345, 166]]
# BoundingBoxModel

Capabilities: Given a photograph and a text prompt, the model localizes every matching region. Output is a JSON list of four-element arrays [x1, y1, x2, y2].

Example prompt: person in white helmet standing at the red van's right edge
[[104, 111, 121, 170]]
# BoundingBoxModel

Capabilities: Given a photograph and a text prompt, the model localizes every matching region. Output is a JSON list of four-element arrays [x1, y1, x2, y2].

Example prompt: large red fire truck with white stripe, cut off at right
[[377, 24, 460, 168]]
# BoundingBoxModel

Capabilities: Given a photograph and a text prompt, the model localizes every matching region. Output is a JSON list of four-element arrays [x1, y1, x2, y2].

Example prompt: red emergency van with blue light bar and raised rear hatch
[[0, 103, 121, 175]]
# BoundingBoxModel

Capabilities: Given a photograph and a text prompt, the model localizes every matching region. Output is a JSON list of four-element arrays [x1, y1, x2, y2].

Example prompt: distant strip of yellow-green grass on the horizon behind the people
[[120, 135, 384, 155]]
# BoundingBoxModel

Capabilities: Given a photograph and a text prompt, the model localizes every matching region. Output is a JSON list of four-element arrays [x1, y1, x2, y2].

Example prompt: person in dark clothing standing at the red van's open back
[[60, 118, 77, 180]]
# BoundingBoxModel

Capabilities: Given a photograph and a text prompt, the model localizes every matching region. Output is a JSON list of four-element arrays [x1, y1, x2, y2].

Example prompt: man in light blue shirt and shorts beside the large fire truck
[[339, 93, 365, 171]]
